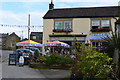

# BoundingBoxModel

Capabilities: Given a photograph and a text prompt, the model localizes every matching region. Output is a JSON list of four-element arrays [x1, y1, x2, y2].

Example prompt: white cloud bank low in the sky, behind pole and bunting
[[0, 10, 45, 38]]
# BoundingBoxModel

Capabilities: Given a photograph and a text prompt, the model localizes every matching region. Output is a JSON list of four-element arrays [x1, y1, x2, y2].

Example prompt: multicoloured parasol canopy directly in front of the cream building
[[44, 41, 70, 48]]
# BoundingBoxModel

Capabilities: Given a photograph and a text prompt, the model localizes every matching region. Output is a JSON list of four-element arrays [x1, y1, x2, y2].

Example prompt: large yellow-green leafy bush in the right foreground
[[72, 47, 112, 78]]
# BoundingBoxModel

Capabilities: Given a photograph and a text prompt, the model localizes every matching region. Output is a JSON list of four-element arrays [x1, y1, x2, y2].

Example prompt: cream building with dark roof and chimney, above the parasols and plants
[[43, 3, 118, 51]]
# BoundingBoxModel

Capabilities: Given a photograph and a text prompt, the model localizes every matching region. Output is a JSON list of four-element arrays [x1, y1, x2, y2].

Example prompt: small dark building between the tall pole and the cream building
[[30, 32, 43, 43]]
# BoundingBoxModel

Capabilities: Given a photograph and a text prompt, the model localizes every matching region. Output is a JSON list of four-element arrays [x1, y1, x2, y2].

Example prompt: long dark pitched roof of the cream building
[[43, 6, 120, 19]]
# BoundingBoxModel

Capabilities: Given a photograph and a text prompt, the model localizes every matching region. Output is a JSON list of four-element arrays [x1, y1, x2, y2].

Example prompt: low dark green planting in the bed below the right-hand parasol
[[45, 53, 73, 65]]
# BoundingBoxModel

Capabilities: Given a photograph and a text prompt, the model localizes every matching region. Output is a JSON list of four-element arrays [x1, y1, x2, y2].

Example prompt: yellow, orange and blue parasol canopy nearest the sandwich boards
[[16, 40, 42, 47]]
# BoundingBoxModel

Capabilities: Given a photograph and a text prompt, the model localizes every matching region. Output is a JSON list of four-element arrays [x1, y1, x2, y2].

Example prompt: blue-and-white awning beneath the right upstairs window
[[90, 32, 110, 40]]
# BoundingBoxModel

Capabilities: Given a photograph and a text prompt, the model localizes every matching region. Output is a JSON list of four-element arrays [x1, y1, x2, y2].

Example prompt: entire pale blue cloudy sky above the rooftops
[[0, 0, 120, 38]]
